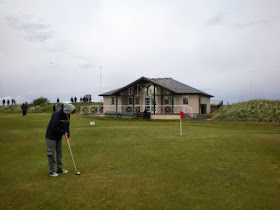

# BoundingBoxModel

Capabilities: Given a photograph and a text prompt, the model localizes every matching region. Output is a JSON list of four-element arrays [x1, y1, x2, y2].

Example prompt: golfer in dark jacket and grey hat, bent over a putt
[[46, 104, 75, 177]]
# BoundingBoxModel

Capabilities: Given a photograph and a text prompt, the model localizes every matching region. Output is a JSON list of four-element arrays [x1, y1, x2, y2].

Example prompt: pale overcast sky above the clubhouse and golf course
[[0, 0, 280, 105]]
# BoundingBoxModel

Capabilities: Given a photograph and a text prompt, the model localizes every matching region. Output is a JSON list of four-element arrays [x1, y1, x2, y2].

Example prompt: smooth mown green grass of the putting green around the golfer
[[0, 113, 280, 209]]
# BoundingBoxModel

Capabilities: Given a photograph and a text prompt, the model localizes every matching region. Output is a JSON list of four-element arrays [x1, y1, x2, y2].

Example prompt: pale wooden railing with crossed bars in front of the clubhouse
[[81, 105, 194, 117]]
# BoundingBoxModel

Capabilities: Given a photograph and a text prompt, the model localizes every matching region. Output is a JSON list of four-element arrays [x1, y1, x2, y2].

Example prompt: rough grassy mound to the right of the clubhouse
[[214, 100, 280, 122]]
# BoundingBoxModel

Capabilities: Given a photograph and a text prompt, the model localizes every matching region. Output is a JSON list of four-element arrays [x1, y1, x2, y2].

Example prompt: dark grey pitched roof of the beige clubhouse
[[99, 77, 213, 97]]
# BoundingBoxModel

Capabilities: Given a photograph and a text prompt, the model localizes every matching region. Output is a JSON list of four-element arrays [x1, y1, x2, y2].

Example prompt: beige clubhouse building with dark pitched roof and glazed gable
[[96, 77, 213, 119]]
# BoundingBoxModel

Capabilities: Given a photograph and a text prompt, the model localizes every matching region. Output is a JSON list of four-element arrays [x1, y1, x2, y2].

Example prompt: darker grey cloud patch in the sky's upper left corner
[[6, 16, 54, 42]]
